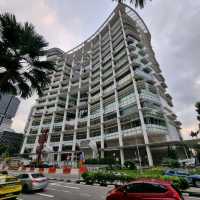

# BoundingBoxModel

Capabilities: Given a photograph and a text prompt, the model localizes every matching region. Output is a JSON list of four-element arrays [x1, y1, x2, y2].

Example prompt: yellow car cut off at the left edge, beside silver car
[[0, 174, 22, 200]]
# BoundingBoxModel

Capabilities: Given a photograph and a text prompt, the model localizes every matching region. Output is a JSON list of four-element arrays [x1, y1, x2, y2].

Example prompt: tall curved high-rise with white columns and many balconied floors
[[21, 4, 181, 166]]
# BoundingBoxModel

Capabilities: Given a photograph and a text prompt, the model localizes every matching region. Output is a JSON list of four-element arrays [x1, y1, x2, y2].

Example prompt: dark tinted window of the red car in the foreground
[[126, 183, 167, 193]]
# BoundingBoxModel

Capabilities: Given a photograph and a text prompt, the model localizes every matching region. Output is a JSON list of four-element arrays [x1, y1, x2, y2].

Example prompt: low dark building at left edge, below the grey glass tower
[[0, 130, 24, 156]]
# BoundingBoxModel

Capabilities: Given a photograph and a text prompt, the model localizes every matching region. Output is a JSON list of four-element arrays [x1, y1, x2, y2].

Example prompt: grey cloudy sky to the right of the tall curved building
[[140, 0, 200, 138]]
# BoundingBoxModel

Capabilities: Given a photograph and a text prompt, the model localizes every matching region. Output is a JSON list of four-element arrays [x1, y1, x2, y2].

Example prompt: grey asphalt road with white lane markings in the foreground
[[18, 181, 200, 200]]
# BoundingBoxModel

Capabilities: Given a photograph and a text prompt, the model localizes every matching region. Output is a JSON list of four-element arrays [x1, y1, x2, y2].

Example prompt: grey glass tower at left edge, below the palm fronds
[[0, 94, 20, 131]]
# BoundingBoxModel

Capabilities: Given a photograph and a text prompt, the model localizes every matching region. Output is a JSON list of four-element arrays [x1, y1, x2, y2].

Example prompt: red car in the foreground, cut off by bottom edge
[[106, 180, 186, 200]]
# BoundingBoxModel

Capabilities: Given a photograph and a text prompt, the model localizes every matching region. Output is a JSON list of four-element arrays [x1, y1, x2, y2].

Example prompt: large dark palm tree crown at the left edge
[[0, 13, 55, 98]]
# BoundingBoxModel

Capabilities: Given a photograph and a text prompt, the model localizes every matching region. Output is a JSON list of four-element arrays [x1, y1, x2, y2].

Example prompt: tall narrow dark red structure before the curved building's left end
[[36, 129, 49, 164]]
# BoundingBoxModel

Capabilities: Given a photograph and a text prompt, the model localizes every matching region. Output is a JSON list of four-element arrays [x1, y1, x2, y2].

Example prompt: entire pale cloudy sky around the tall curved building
[[0, 0, 200, 138]]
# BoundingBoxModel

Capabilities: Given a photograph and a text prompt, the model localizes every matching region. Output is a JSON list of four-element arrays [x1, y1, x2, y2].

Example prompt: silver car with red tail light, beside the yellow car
[[16, 172, 48, 192]]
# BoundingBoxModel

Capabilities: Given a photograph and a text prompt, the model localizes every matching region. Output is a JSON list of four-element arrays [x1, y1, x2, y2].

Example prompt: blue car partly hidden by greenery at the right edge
[[165, 169, 200, 187]]
